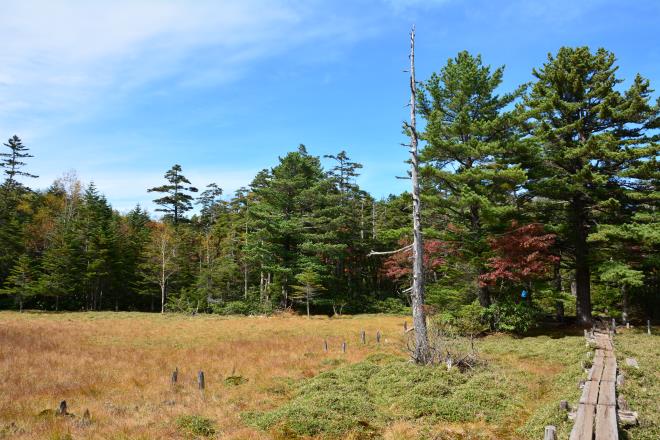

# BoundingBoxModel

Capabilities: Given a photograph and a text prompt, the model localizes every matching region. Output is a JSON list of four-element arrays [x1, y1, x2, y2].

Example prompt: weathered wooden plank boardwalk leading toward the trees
[[570, 333, 619, 440]]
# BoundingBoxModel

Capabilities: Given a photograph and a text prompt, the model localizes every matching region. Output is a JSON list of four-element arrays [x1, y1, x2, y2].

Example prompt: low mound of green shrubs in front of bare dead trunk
[[243, 354, 520, 438]]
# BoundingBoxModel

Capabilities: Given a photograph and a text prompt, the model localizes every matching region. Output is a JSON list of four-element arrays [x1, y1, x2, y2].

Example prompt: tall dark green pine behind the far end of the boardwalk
[[523, 47, 658, 324]]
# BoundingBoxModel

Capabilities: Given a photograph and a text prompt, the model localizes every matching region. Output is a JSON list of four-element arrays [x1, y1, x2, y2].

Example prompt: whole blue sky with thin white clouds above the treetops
[[0, 0, 660, 211]]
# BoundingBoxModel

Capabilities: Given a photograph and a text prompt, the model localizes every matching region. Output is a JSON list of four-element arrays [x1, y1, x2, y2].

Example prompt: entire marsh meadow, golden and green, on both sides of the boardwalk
[[0, 312, 658, 440]]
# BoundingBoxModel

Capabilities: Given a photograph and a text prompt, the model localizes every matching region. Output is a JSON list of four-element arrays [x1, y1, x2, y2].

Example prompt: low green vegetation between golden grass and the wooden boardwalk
[[244, 335, 584, 439]]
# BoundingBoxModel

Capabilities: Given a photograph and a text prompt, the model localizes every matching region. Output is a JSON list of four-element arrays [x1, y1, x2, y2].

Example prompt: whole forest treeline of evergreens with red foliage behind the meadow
[[0, 47, 660, 328]]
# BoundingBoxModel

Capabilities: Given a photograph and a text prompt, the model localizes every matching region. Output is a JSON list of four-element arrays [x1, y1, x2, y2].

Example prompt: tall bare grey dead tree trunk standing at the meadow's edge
[[408, 26, 431, 364]]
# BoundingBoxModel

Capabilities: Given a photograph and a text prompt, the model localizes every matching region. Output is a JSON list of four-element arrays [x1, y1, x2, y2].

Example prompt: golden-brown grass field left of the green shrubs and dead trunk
[[0, 312, 404, 439]]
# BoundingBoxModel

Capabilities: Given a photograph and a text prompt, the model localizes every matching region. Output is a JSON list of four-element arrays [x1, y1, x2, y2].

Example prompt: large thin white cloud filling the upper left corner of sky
[[0, 0, 364, 138]]
